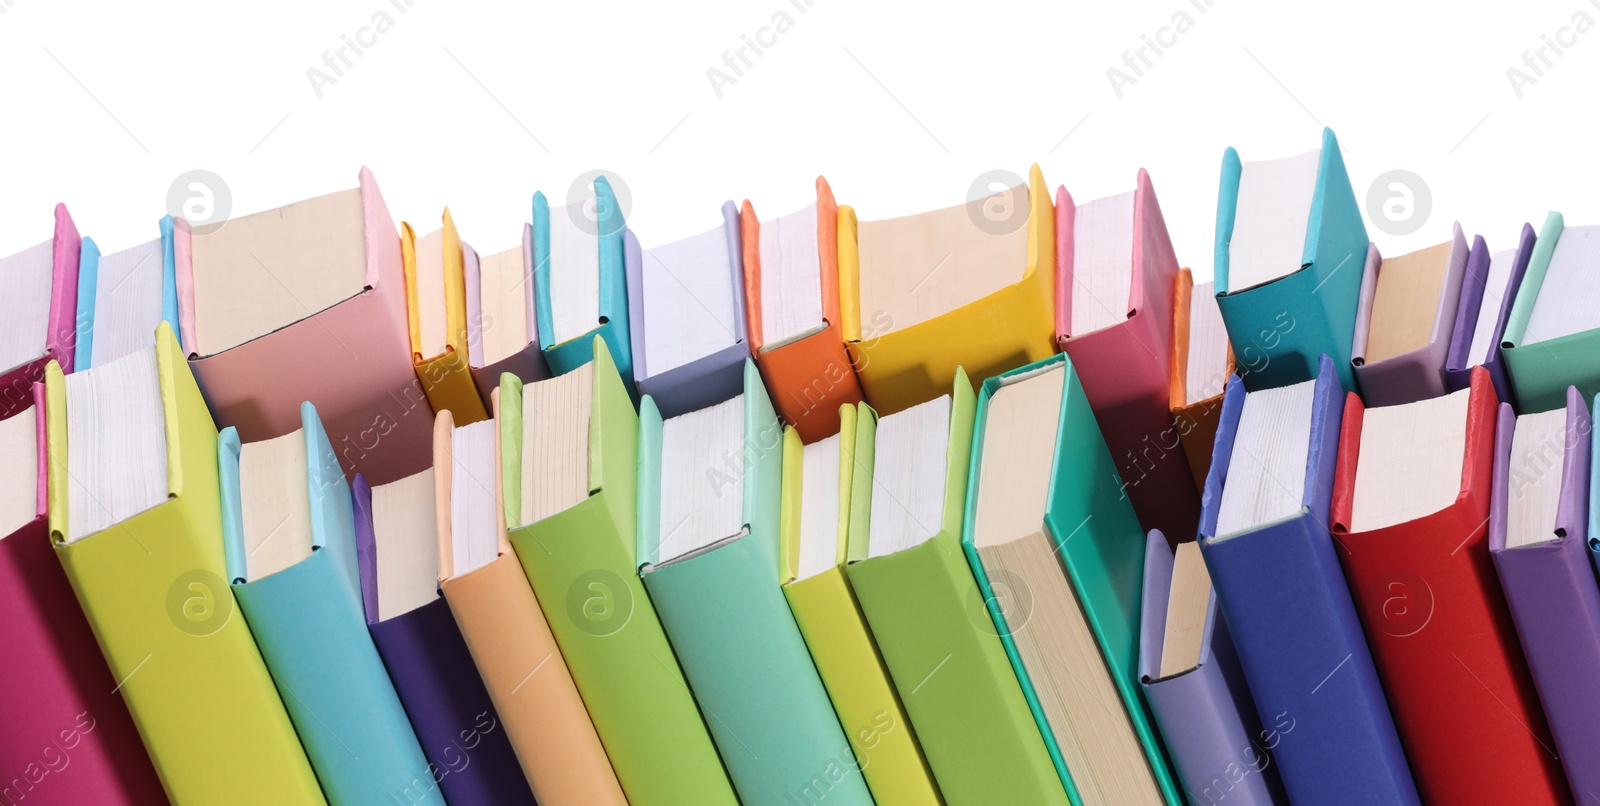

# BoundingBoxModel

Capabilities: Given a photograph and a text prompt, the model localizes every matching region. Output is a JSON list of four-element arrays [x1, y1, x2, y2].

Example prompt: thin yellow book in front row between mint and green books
[[778, 405, 944, 804]]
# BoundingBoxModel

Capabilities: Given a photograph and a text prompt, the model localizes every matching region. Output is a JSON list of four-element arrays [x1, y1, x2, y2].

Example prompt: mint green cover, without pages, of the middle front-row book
[[638, 360, 872, 806]]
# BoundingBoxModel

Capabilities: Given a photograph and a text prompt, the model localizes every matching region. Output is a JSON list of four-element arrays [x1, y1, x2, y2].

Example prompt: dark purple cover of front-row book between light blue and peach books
[[350, 473, 534, 804]]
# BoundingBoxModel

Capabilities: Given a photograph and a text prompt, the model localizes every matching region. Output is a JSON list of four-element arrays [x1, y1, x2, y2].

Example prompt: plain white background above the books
[[0, 0, 1600, 278]]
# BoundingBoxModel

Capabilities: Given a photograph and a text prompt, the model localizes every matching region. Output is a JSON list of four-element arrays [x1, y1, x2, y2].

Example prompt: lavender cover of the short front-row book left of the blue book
[[1139, 529, 1288, 806]]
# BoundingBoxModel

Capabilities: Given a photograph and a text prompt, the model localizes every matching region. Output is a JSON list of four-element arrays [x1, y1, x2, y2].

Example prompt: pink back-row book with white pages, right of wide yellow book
[[1056, 168, 1200, 539]]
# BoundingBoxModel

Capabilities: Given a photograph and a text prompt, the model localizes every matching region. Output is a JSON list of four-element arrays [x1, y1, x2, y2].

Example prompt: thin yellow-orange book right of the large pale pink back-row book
[[400, 208, 488, 425]]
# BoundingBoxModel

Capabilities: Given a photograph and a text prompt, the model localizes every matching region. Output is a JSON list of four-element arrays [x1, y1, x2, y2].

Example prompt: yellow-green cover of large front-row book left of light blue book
[[45, 325, 325, 804]]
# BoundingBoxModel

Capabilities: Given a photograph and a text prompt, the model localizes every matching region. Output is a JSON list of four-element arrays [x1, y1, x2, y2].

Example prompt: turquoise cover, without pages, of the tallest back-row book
[[1216, 128, 1368, 392]]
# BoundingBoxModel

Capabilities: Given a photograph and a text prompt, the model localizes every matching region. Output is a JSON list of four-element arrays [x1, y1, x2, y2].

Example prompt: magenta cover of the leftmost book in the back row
[[0, 205, 83, 418]]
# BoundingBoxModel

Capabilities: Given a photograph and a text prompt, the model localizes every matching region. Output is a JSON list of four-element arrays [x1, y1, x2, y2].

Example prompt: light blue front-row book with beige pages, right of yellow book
[[218, 403, 445, 806]]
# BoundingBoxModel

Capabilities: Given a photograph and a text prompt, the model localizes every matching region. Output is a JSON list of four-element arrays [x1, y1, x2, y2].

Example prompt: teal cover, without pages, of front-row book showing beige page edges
[[962, 353, 1184, 806]]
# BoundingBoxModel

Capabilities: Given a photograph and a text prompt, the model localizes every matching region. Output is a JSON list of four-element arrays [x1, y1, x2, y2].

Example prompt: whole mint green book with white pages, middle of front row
[[638, 360, 872, 804]]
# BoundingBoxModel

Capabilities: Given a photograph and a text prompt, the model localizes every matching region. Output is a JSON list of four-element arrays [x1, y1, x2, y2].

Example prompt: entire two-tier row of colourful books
[[0, 124, 1600, 804]]
